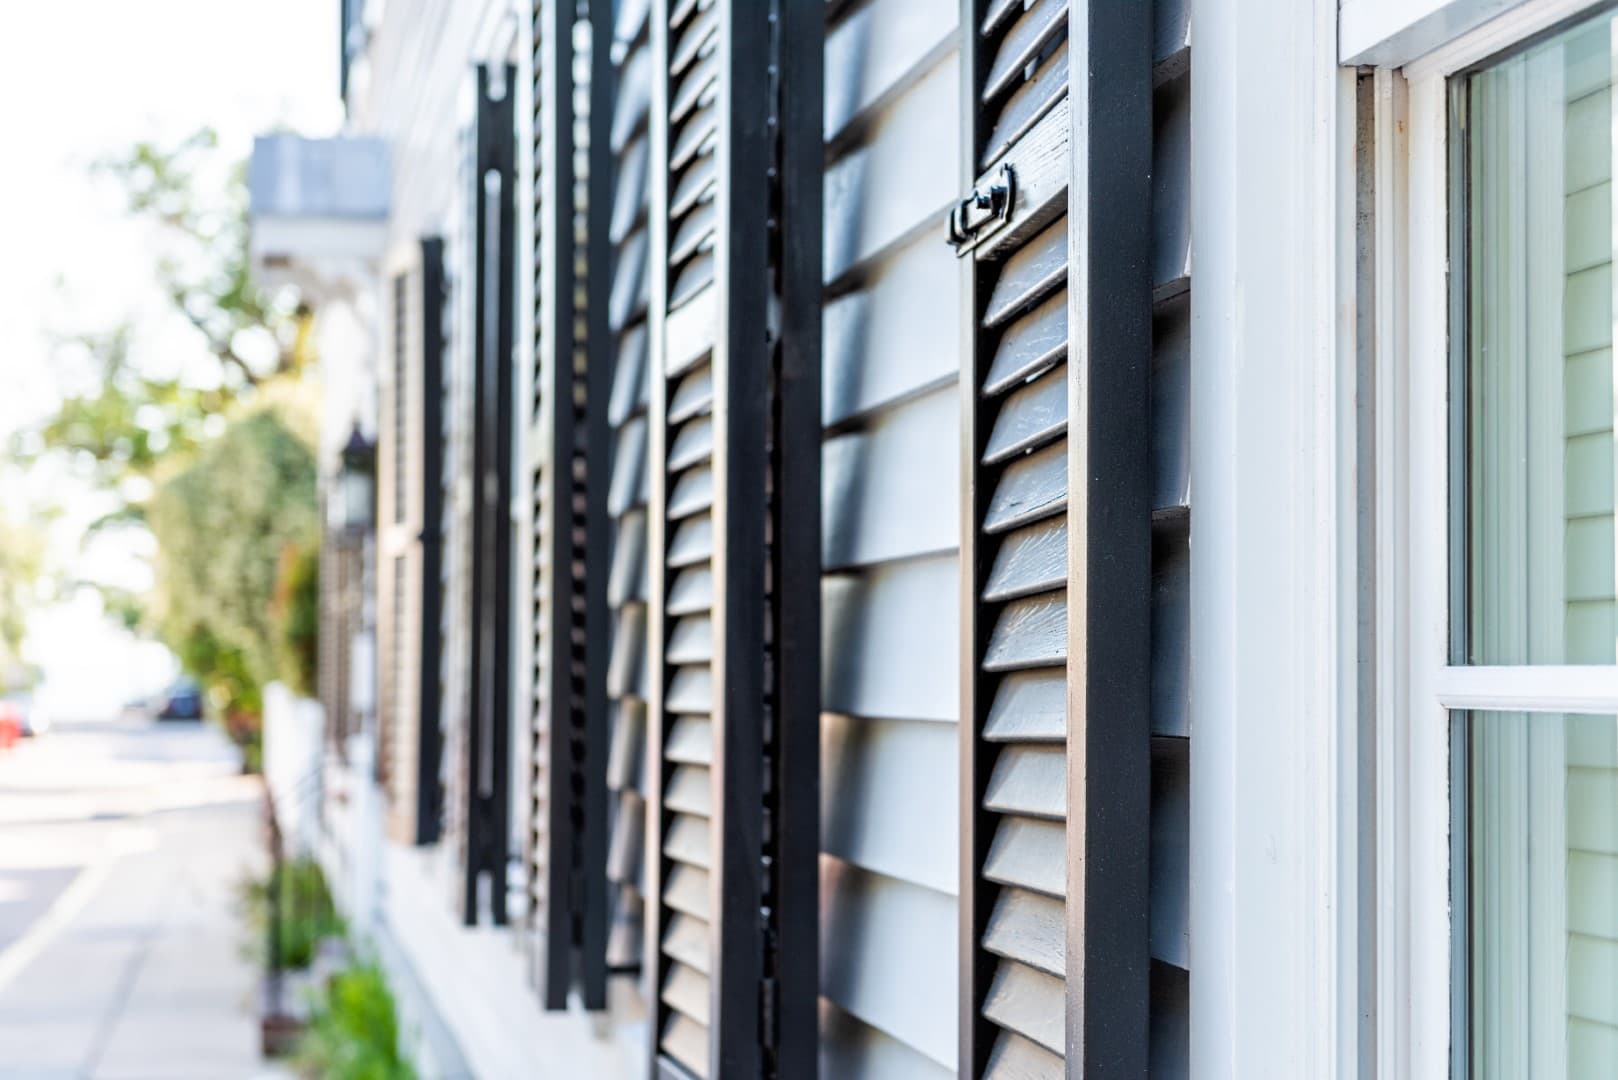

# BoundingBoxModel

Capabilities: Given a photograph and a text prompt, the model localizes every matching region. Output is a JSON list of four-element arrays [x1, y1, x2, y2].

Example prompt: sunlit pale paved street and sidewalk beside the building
[[0, 721, 279, 1080]]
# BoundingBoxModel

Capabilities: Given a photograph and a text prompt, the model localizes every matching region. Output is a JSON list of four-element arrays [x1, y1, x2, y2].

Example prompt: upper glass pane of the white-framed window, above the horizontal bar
[[1451, 15, 1618, 664]]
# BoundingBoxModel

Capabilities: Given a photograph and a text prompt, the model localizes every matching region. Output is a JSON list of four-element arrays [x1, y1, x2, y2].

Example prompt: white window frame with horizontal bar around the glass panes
[[1375, 0, 1618, 1077]]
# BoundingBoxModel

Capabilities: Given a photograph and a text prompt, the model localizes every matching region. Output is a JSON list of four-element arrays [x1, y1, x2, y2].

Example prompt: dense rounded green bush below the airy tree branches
[[147, 408, 319, 746]]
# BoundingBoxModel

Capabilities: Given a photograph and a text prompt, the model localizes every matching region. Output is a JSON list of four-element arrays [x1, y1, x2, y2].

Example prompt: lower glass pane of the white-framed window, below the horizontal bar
[[1453, 712, 1618, 1080]]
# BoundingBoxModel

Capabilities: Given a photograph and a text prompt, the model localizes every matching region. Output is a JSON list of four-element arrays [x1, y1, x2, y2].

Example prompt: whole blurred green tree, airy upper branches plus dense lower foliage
[[13, 130, 319, 758]]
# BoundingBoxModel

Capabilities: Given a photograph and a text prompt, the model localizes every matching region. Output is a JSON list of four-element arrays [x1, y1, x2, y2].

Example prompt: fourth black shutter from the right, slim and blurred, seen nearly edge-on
[[458, 65, 516, 925]]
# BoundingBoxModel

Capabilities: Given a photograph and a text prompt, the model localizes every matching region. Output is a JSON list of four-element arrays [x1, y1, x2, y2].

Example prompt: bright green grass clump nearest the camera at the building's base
[[293, 963, 416, 1080]]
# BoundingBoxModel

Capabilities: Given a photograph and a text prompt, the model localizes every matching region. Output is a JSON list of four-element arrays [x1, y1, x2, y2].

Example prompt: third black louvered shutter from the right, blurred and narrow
[[527, 0, 612, 1009]]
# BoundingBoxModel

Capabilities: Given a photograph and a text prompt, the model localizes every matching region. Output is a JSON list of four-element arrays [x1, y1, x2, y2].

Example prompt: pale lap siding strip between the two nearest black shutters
[[820, 0, 959, 1077]]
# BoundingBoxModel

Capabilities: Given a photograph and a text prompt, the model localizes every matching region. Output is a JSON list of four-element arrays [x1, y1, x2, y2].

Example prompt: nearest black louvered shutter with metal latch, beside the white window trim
[[950, 0, 1154, 1077]]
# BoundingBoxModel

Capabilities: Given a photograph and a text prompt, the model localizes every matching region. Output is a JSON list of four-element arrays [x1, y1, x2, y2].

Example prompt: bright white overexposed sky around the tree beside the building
[[0, 0, 341, 712]]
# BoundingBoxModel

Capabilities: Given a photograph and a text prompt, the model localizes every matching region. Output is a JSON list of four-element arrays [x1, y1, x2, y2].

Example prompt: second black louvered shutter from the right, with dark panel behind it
[[647, 0, 824, 1077]]
